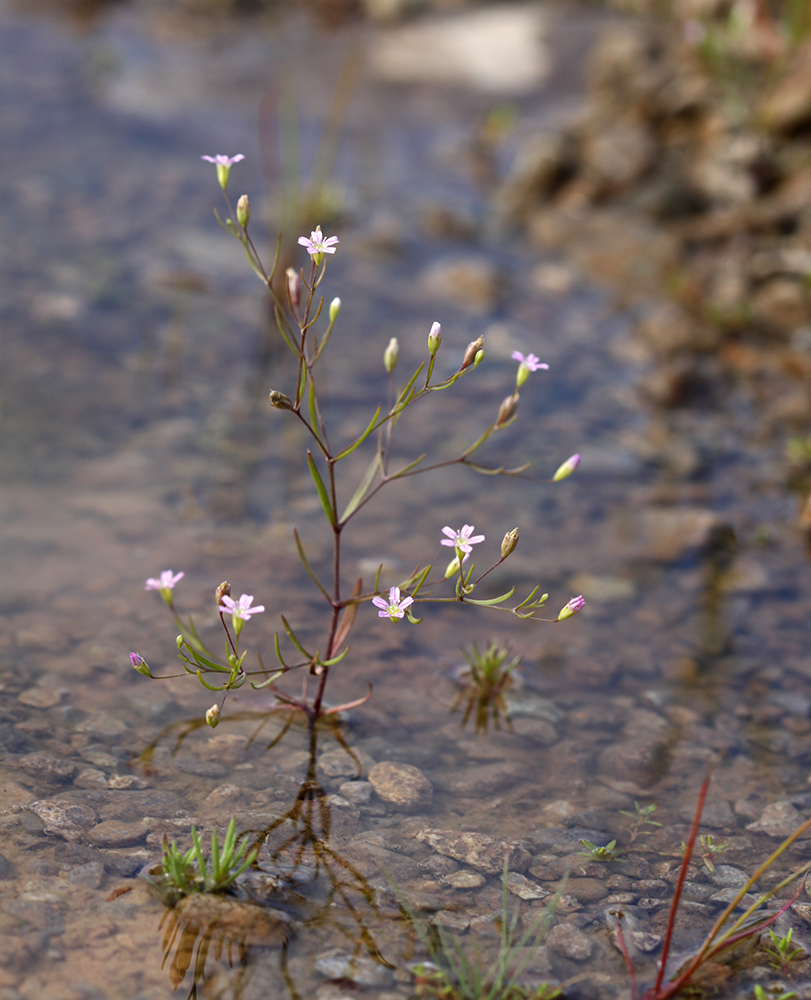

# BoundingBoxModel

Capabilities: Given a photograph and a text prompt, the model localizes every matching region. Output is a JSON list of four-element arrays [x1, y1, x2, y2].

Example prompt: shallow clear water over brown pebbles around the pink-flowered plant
[[0, 0, 811, 1000]]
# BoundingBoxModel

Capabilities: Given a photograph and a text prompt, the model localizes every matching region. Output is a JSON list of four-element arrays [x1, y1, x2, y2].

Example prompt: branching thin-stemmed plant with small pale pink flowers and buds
[[130, 160, 585, 726]]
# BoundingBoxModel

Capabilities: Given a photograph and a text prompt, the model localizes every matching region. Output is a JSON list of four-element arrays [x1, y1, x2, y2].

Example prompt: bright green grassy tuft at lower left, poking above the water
[[150, 819, 257, 906]]
